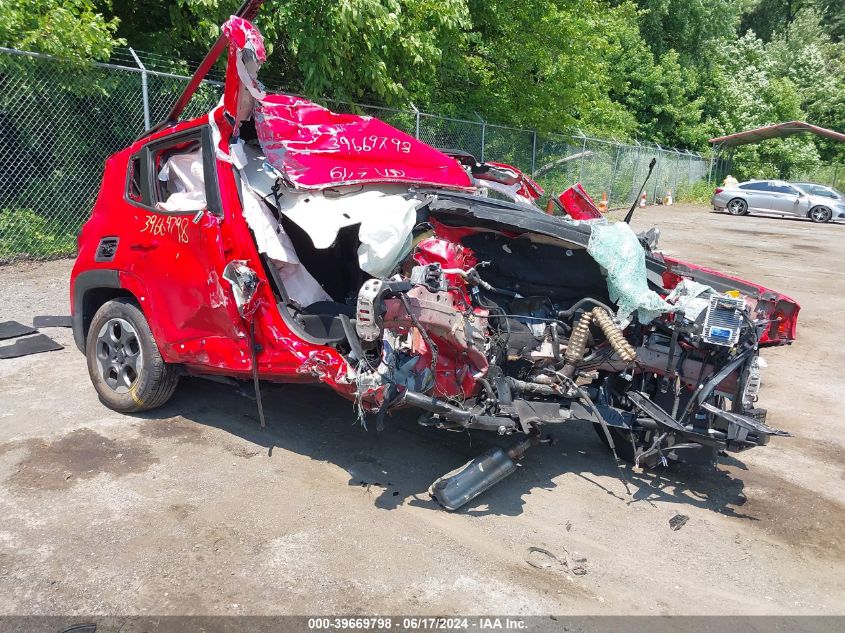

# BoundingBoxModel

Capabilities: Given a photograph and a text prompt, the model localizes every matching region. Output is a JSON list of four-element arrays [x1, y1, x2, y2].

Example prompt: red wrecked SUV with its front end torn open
[[71, 3, 799, 509]]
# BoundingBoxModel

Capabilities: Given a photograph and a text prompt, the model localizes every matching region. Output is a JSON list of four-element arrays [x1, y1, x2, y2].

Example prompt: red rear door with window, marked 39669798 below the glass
[[127, 125, 246, 367]]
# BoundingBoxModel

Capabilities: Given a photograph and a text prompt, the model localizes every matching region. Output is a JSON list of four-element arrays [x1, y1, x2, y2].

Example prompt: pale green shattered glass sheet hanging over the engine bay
[[587, 222, 674, 323]]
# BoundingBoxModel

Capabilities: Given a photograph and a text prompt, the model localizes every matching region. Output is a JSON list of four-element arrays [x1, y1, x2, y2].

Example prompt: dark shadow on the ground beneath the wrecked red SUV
[[136, 378, 753, 519]]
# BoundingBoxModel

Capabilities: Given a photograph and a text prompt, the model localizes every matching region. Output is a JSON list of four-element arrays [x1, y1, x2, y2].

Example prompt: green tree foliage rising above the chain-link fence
[[0, 0, 845, 176]]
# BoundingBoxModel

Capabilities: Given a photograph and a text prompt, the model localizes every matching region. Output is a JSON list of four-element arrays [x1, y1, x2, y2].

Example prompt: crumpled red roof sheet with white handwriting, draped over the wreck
[[255, 95, 473, 190]]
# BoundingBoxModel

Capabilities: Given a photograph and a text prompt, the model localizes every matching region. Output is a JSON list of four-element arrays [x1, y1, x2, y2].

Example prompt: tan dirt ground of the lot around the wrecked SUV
[[0, 206, 845, 615]]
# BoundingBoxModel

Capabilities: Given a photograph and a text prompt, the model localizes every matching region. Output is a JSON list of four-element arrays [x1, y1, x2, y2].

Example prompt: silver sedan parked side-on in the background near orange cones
[[712, 180, 845, 222]]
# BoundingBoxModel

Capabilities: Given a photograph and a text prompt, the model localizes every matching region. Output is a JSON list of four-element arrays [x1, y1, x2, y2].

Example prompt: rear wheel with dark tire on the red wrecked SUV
[[85, 298, 179, 413]]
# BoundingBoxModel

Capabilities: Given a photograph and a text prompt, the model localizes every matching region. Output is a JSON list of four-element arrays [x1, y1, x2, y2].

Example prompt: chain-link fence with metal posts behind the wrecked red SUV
[[0, 48, 724, 263]]
